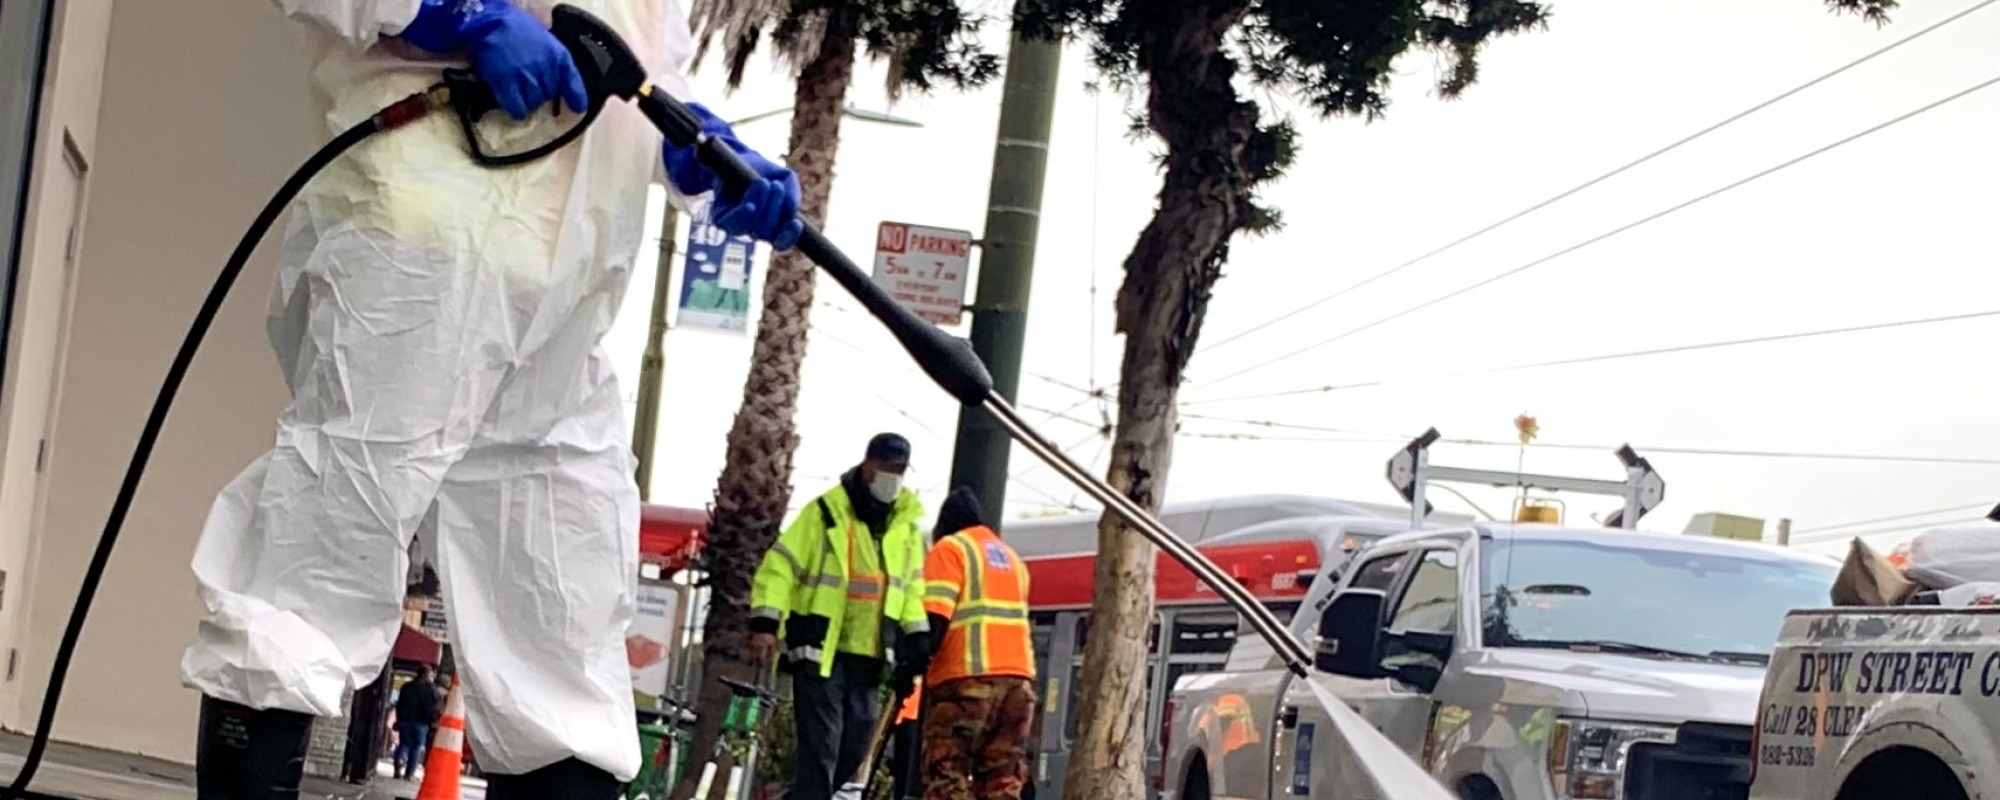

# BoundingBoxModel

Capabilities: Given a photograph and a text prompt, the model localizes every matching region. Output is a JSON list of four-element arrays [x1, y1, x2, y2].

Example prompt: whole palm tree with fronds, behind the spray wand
[[676, 0, 1000, 798]]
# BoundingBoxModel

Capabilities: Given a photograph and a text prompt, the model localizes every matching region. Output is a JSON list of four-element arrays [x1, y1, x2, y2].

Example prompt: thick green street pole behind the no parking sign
[[950, 30, 1062, 520]]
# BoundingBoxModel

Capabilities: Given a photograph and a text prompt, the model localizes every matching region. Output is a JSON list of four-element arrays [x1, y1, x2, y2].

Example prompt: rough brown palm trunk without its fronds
[[674, 24, 854, 800]]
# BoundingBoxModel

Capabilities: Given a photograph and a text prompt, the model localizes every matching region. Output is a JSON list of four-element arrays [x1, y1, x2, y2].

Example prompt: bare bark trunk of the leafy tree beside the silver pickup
[[1062, 0, 1258, 800]]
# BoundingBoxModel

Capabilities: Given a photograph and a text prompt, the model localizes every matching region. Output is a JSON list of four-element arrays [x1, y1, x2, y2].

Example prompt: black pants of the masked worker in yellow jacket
[[786, 652, 882, 800]]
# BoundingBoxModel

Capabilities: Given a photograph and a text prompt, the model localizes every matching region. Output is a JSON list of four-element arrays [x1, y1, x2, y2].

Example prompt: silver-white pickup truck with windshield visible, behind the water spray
[[1160, 524, 1838, 800]]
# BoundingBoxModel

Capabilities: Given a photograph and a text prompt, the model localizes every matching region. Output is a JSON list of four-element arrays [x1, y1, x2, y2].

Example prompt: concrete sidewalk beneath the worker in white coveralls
[[0, 732, 386, 800]]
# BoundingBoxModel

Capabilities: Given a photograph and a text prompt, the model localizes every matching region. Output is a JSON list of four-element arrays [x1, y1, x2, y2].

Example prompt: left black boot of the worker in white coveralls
[[194, 696, 312, 800]]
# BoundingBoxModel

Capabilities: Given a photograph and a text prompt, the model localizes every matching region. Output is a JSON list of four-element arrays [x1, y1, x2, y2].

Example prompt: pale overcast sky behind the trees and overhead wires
[[608, 0, 2000, 550]]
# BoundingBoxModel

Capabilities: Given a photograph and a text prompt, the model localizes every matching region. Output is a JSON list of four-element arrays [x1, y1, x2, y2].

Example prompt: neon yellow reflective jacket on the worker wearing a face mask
[[750, 484, 930, 676]]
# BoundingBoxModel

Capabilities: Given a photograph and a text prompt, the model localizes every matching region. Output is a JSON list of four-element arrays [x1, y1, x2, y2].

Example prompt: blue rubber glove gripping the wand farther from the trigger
[[660, 102, 806, 250]]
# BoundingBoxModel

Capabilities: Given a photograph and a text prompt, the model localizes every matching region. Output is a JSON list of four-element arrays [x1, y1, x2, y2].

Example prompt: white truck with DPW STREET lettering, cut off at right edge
[[1750, 606, 2000, 800]]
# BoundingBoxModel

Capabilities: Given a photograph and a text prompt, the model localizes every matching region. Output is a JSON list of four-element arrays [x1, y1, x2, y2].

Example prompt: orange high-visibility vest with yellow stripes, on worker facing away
[[924, 526, 1034, 686]]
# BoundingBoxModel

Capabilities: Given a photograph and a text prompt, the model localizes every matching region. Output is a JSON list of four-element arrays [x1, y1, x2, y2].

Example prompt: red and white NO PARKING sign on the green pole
[[874, 222, 972, 326]]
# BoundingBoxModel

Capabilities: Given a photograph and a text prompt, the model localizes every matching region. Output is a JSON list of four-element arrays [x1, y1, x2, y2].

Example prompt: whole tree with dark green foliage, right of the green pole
[[1014, 0, 1896, 800]]
